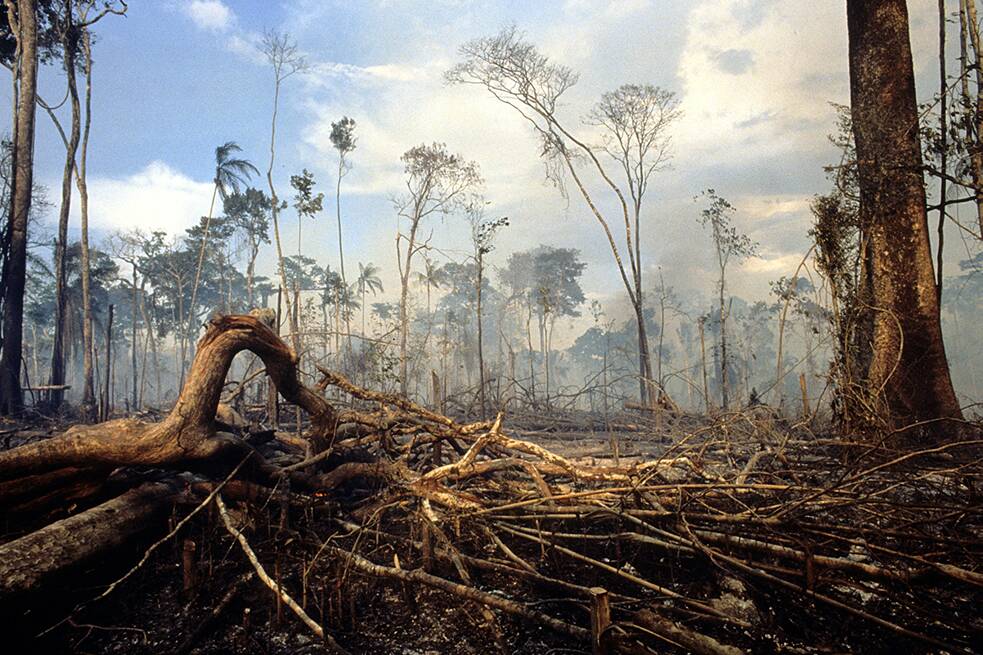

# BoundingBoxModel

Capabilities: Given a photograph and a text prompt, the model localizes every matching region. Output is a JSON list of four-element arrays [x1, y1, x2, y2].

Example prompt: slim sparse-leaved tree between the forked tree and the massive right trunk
[[700, 189, 757, 411]]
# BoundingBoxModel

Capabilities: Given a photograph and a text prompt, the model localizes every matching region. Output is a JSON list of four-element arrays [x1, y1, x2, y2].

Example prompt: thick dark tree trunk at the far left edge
[[0, 0, 38, 414]]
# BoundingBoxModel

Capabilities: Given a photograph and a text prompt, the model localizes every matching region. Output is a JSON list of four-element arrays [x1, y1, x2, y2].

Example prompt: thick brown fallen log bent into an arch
[[0, 315, 338, 504]]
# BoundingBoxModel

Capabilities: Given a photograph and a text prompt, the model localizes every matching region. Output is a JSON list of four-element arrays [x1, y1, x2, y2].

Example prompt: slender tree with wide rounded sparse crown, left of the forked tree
[[393, 143, 481, 395]]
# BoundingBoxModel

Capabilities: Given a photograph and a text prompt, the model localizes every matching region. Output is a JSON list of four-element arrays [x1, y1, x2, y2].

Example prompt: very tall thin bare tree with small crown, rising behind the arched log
[[261, 31, 309, 352]]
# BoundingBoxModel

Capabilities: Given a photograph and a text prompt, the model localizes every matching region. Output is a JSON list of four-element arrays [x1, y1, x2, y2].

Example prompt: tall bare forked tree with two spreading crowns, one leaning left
[[446, 26, 680, 404]]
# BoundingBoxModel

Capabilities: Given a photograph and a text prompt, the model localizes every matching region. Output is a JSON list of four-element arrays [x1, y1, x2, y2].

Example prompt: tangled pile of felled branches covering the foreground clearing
[[0, 317, 983, 655]]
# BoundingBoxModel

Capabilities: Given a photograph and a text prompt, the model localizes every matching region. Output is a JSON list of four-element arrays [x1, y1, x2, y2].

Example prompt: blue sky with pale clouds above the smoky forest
[[11, 0, 966, 344]]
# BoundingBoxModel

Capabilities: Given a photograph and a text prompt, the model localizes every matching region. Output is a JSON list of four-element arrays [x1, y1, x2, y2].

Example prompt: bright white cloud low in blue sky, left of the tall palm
[[72, 161, 212, 235]]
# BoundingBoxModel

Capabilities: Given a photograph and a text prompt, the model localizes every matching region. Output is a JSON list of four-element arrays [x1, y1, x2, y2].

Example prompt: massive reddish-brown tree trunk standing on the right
[[847, 0, 962, 432]]
